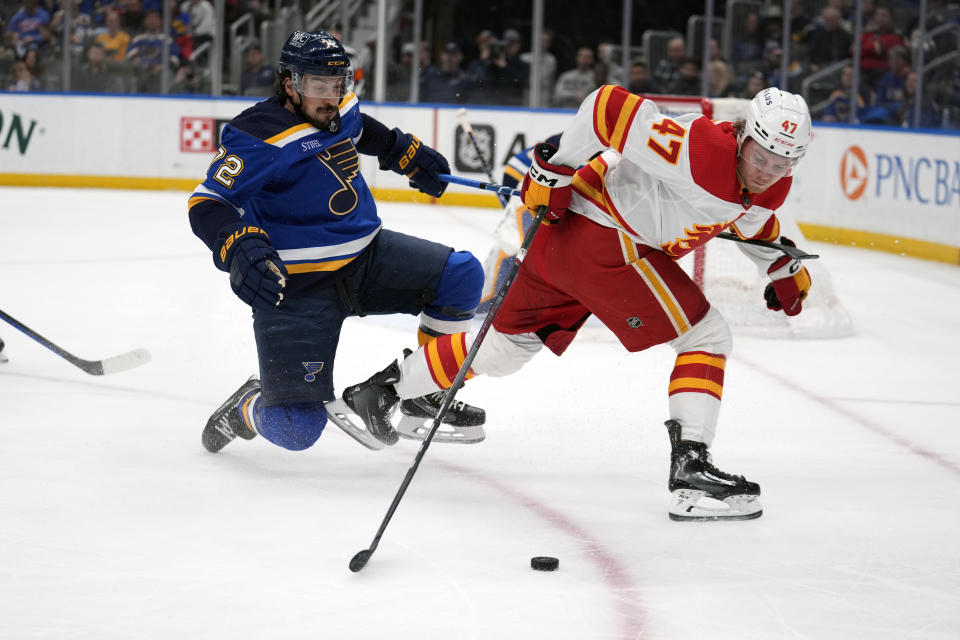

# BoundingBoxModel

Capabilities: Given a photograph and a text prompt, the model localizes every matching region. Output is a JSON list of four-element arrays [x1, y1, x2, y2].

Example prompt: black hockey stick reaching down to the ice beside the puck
[[350, 206, 547, 573]]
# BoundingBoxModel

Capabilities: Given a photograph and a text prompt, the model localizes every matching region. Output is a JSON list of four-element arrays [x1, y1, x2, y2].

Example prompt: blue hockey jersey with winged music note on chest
[[189, 94, 382, 274]]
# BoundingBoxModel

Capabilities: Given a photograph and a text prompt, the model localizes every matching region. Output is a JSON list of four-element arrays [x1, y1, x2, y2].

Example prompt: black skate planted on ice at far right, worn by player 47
[[666, 420, 763, 520]]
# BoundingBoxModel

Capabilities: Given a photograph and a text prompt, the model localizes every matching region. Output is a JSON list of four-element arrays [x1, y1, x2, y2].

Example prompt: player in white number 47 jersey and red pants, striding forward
[[342, 85, 811, 520]]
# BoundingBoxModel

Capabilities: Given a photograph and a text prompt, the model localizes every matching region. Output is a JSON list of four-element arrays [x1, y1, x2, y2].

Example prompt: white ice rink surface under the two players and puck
[[0, 188, 960, 640]]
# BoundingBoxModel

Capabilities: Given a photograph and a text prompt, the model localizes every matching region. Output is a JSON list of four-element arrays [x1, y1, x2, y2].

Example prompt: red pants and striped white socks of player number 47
[[396, 215, 732, 446]]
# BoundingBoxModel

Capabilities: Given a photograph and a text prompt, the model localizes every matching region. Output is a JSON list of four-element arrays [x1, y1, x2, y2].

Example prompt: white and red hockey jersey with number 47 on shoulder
[[551, 85, 793, 264]]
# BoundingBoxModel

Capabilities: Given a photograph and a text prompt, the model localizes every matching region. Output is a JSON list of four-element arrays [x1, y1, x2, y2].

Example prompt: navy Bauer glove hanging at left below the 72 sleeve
[[213, 222, 288, 310]]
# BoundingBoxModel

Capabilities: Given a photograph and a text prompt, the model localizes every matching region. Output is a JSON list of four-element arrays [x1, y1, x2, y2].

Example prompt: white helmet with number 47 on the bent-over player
[[737, 87, 811, 164]]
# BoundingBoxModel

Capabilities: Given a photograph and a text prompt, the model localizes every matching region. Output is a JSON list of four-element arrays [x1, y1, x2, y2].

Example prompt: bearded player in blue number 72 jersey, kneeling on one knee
[[189, 31, 485, 452]]
